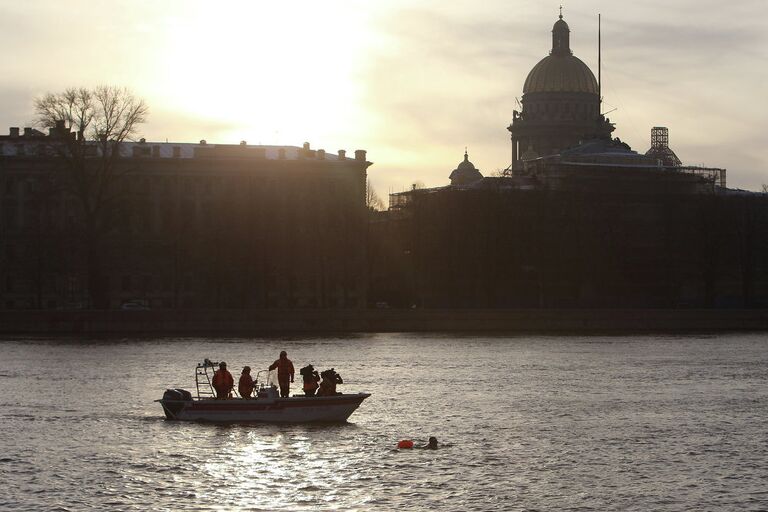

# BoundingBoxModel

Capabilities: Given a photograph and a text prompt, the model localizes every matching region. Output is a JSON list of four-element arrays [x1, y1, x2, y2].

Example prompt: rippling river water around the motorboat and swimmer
[[0, 334, 768, 511]]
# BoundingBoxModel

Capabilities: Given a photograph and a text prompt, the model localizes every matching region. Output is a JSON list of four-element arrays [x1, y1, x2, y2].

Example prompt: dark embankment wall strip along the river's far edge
[[0, 309, 768, 335]]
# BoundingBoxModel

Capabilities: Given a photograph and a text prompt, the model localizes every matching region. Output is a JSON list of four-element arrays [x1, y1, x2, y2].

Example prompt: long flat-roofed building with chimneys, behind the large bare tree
[[0, 123, 371, 309]]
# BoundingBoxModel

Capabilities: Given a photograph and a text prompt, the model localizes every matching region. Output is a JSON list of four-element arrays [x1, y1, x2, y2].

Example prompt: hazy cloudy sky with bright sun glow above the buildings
[[0, 0, 768, 196]]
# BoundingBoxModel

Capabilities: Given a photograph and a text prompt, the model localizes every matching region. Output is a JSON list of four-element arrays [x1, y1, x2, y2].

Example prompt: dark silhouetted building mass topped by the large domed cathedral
[[370, 16, 768, 308]]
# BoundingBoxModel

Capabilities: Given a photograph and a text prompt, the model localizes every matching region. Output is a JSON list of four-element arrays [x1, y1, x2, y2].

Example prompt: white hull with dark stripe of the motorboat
[[157, 393, 371, 423]]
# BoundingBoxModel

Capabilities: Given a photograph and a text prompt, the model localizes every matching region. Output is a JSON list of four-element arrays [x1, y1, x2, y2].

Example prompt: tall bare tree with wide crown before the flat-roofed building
[[34, 86, 149, 309]]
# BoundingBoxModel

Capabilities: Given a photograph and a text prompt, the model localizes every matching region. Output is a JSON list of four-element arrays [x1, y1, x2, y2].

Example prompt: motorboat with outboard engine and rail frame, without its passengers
[[155, 359, 371, 423]]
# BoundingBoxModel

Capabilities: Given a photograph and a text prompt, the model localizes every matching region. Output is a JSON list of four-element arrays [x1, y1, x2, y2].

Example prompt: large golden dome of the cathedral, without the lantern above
[[523, 55, 597, 94]]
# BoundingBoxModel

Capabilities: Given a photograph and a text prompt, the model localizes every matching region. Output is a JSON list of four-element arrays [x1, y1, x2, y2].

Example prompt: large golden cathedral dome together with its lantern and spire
[[523, 14, 598, 94]]
